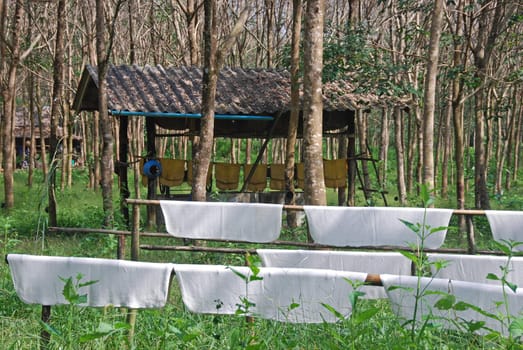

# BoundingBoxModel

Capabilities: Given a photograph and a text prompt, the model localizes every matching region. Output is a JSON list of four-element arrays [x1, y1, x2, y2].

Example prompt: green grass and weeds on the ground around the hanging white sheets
[[0, 172, 523, 349]]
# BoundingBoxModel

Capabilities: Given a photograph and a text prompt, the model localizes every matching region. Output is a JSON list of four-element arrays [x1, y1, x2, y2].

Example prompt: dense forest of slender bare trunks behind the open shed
[[0, 0, 523, 230]]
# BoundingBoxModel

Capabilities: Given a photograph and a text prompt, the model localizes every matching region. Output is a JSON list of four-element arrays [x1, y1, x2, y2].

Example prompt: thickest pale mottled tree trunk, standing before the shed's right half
[[303, 0, 327, 205]]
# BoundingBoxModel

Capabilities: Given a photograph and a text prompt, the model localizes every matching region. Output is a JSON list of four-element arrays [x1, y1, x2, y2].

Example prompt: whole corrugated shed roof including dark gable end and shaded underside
[[73, 65, 410, 137]]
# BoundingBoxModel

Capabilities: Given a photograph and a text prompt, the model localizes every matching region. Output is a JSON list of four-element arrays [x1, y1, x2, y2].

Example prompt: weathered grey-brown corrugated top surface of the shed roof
[[73, 65, 404, 115]]
